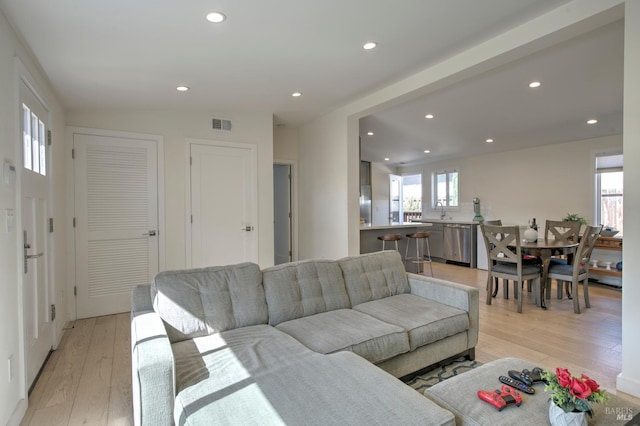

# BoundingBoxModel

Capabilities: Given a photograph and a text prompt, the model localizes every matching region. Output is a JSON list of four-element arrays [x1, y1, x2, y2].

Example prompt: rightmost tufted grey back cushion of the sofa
[[338, 250, 410, 306]]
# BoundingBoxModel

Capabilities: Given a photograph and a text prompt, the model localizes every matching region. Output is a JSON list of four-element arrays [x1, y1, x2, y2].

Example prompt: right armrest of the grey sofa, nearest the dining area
[[407, 273, 480, 348]]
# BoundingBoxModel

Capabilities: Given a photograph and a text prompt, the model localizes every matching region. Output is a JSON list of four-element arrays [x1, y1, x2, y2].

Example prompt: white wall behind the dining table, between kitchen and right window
[[399, 135, 622, 225]]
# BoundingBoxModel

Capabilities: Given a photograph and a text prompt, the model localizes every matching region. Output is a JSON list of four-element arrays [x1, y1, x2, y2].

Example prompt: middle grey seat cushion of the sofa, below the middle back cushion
[[276, 309, 409, 363]]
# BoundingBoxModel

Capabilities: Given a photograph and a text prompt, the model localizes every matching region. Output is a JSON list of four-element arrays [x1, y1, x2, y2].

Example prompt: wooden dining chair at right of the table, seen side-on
[[547, 225, 602, 314]]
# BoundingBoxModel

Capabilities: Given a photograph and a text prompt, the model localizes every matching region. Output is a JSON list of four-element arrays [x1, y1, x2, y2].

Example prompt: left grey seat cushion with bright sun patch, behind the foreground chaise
[[171, 325, 315, 393]]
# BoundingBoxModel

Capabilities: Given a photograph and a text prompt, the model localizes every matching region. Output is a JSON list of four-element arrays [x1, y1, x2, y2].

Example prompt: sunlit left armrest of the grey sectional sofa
[[131, 285, 175, 425]]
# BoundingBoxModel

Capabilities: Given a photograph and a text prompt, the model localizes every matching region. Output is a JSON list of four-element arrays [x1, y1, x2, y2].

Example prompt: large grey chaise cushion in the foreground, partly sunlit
[[174, 352, 455, 426]]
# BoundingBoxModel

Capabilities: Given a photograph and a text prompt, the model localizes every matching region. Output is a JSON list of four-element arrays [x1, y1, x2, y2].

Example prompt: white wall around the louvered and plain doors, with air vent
[[67, 110, 273, 269]]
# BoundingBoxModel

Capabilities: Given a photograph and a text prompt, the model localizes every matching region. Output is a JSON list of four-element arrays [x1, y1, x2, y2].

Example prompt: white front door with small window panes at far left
[[20, 83, 54, 387]]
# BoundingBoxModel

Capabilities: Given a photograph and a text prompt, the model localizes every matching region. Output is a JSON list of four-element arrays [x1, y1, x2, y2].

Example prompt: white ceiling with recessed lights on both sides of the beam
[[0, 0, 622, 165]]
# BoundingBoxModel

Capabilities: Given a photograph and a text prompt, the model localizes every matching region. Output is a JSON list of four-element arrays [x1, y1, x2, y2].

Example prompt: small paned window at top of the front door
[[22, 104, 47, 176]]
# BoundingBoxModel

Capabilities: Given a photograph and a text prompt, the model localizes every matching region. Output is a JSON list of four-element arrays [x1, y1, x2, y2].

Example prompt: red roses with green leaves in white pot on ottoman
[[542, 368, 609, 425]]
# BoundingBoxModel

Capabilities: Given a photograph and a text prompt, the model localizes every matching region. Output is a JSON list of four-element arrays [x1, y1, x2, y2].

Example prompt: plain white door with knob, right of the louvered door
[[190, 143, 258, 268]]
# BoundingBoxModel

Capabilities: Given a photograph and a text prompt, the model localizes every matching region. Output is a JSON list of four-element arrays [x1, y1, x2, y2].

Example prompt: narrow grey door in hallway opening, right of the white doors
[[273, 164, 292, 265]]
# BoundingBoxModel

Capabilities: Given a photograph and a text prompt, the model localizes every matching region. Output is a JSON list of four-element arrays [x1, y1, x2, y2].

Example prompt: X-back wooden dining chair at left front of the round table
[[480, 223, 540, 313]]
